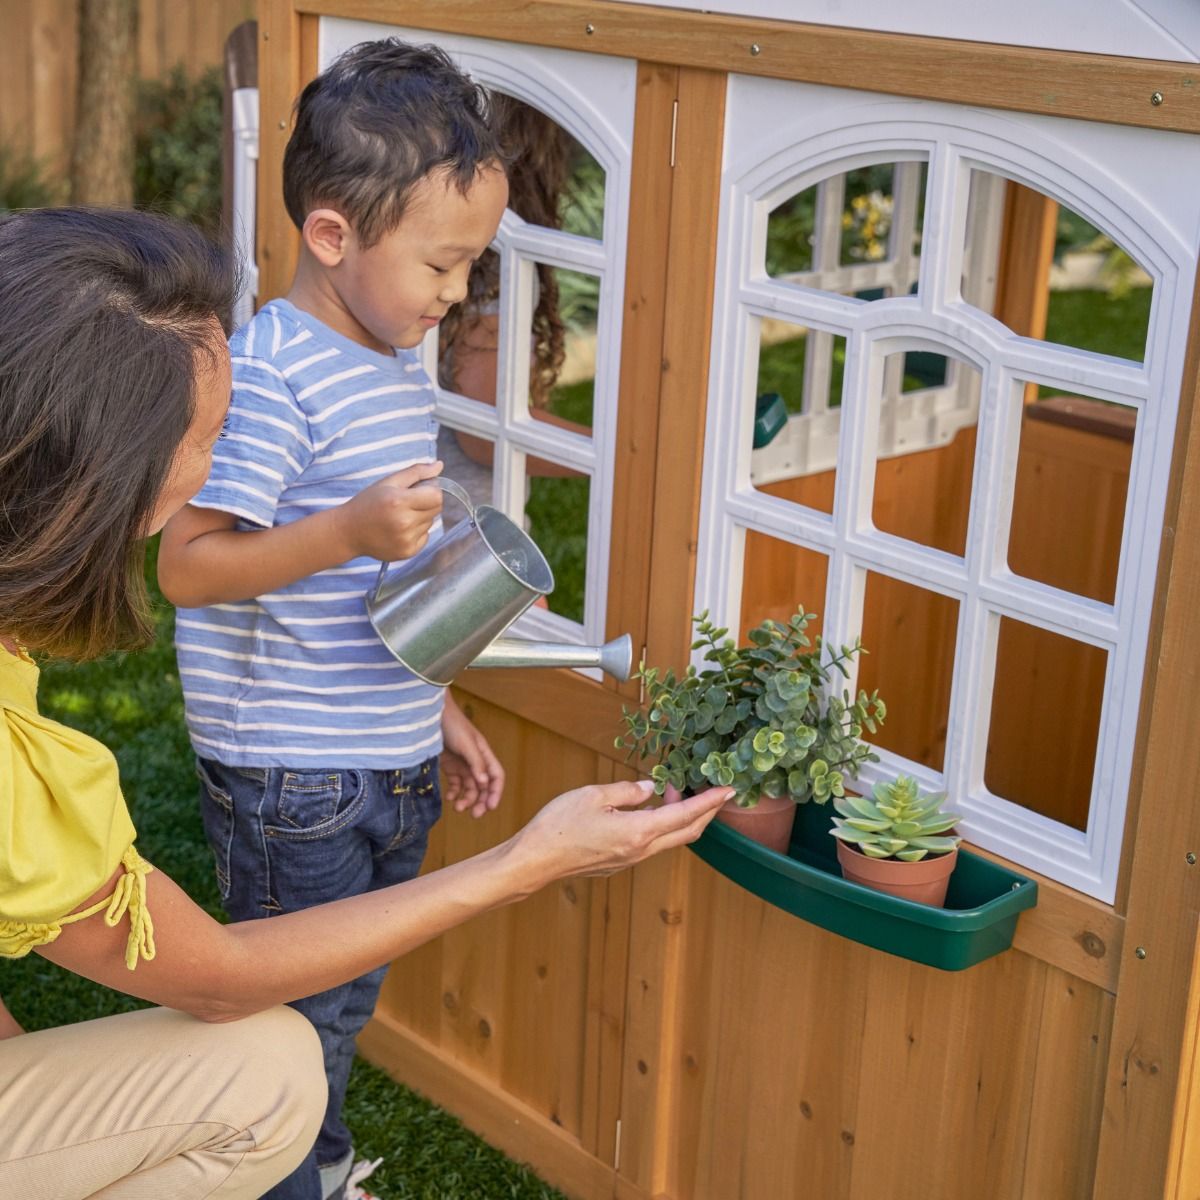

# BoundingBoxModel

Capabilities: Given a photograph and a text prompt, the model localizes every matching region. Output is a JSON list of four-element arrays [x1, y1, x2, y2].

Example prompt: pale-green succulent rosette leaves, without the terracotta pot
[[829, 775, 962, 863]]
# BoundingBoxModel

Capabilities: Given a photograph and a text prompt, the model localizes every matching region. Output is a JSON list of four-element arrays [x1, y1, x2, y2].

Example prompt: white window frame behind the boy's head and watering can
[[318, 17, 637, 657]]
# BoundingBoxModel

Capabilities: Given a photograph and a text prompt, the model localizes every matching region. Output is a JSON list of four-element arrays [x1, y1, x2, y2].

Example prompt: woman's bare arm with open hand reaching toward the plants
[[38, 784, 731, 1021]]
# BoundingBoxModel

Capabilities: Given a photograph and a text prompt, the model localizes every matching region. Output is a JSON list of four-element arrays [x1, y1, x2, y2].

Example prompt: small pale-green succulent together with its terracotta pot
[[829, 775, 962, 908]]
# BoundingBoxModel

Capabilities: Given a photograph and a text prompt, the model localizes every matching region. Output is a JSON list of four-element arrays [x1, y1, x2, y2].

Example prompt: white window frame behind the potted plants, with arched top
[[695, 76, 1200, 902]]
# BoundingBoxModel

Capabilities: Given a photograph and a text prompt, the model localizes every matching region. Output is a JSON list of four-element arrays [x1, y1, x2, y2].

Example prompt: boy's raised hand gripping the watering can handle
[[334, 462, 442, 562]]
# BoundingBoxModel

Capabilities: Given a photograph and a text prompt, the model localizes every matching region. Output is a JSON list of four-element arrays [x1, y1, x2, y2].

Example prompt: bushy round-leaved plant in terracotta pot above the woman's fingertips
[[617, 607, 886, 852]]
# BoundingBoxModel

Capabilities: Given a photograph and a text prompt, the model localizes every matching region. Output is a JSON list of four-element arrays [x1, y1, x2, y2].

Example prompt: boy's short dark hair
[[283, 37, 504, 247]]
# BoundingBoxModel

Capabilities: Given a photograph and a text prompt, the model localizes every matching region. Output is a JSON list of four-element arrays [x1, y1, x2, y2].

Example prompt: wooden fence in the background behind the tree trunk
[[0, 0, 250, 179]]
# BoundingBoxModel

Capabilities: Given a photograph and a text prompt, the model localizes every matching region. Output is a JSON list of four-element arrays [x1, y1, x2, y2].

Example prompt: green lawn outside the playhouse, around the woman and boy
[[0, 544, 563, 1200]]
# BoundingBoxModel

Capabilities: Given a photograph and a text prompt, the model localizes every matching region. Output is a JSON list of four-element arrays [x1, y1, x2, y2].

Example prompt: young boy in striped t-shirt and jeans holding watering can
[[158, 38, 508, 1200]]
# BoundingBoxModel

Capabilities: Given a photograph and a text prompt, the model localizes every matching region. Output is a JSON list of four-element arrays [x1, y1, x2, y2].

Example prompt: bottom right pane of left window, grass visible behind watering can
[[526, 460, 590, 623]]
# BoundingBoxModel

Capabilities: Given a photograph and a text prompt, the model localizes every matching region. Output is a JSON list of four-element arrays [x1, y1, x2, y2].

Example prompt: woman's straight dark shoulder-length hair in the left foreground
[[0, 209, 234, 658]]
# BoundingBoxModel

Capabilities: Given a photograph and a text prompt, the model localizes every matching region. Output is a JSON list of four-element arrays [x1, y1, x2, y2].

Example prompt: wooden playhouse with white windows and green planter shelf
[[246, 0, 1200, 1200]]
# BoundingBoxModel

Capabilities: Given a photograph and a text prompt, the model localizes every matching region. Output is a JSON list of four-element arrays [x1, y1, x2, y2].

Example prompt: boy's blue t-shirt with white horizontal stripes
[[175, 300, 443, 770]]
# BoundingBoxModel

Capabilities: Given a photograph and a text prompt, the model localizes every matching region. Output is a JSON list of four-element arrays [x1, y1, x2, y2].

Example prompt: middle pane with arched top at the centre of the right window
[[871, 352, 982, 554]]
